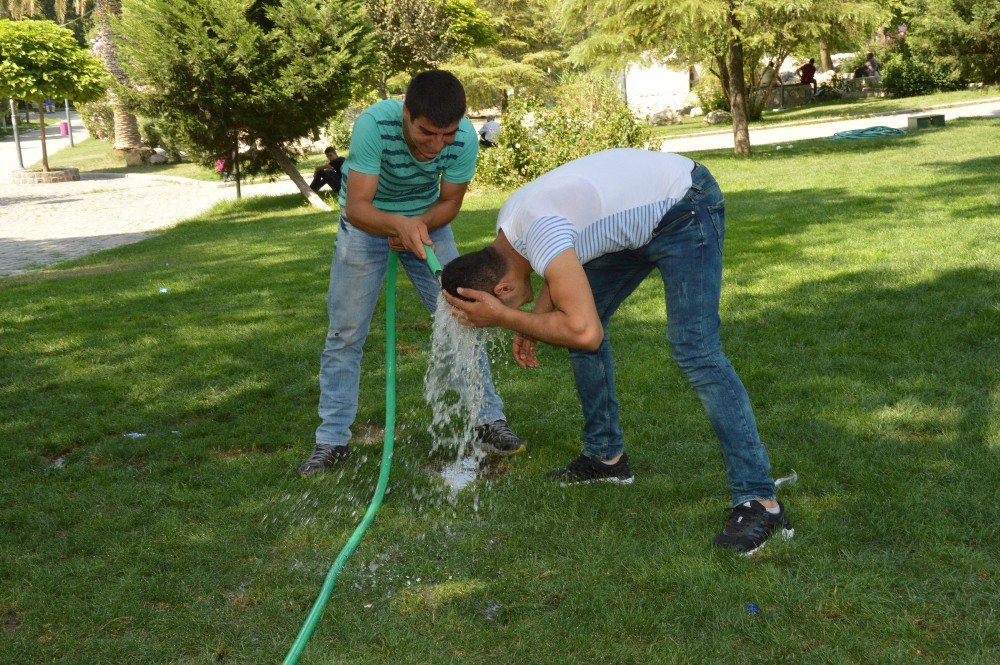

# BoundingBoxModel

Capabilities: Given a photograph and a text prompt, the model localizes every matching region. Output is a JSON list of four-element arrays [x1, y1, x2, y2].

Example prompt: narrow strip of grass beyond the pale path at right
[[653, 86, 1000, 138]]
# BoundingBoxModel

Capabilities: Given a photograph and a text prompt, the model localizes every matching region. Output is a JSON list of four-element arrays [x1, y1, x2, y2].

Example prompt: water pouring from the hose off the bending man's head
[[424, 295, 488, 499]]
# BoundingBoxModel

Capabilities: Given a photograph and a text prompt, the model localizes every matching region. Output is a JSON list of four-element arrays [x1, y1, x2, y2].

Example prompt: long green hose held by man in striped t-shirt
[[284, 245, 441, 665]]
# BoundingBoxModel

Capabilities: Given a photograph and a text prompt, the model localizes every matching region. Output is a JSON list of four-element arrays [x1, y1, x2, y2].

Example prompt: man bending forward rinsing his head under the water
[[442, 148, 793, 554]]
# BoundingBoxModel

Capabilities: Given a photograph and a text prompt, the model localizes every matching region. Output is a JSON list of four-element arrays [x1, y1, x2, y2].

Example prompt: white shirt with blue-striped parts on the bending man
[[497, 148, 694, 275]]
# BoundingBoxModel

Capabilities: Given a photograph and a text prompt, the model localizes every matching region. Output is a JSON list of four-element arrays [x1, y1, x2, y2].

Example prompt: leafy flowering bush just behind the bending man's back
[[474, 87, 659, 189]]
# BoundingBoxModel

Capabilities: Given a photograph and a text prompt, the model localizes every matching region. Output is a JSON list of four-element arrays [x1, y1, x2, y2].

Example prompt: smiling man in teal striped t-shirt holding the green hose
[[299, 69, 525, 475]]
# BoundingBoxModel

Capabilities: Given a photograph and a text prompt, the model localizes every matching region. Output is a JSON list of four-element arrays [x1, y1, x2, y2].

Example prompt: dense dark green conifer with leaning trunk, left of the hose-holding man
[[115, 0, 373, 209]]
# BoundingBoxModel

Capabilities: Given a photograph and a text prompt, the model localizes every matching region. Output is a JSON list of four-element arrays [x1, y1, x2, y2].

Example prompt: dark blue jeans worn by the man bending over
[[570, 164, 774, 505]]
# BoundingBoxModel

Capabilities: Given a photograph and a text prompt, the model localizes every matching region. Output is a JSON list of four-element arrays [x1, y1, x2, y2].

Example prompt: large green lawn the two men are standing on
[[0, 119, 1000, 664]]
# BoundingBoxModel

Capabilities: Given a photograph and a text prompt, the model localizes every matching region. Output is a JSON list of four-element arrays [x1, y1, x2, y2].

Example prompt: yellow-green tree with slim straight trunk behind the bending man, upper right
[[565, 0, 883, 156]]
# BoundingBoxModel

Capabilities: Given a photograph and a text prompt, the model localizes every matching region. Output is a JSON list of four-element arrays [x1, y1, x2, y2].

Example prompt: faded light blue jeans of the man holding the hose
[[316, 215, 504, 446]]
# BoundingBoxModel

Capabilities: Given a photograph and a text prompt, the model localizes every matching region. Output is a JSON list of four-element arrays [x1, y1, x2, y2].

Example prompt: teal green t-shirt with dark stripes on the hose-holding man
[[340, 99, 479, 217]]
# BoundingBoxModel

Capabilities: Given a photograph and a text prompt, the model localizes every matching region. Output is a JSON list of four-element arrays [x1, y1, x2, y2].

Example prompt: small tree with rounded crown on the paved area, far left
[[0, 19, 107, 171]]
